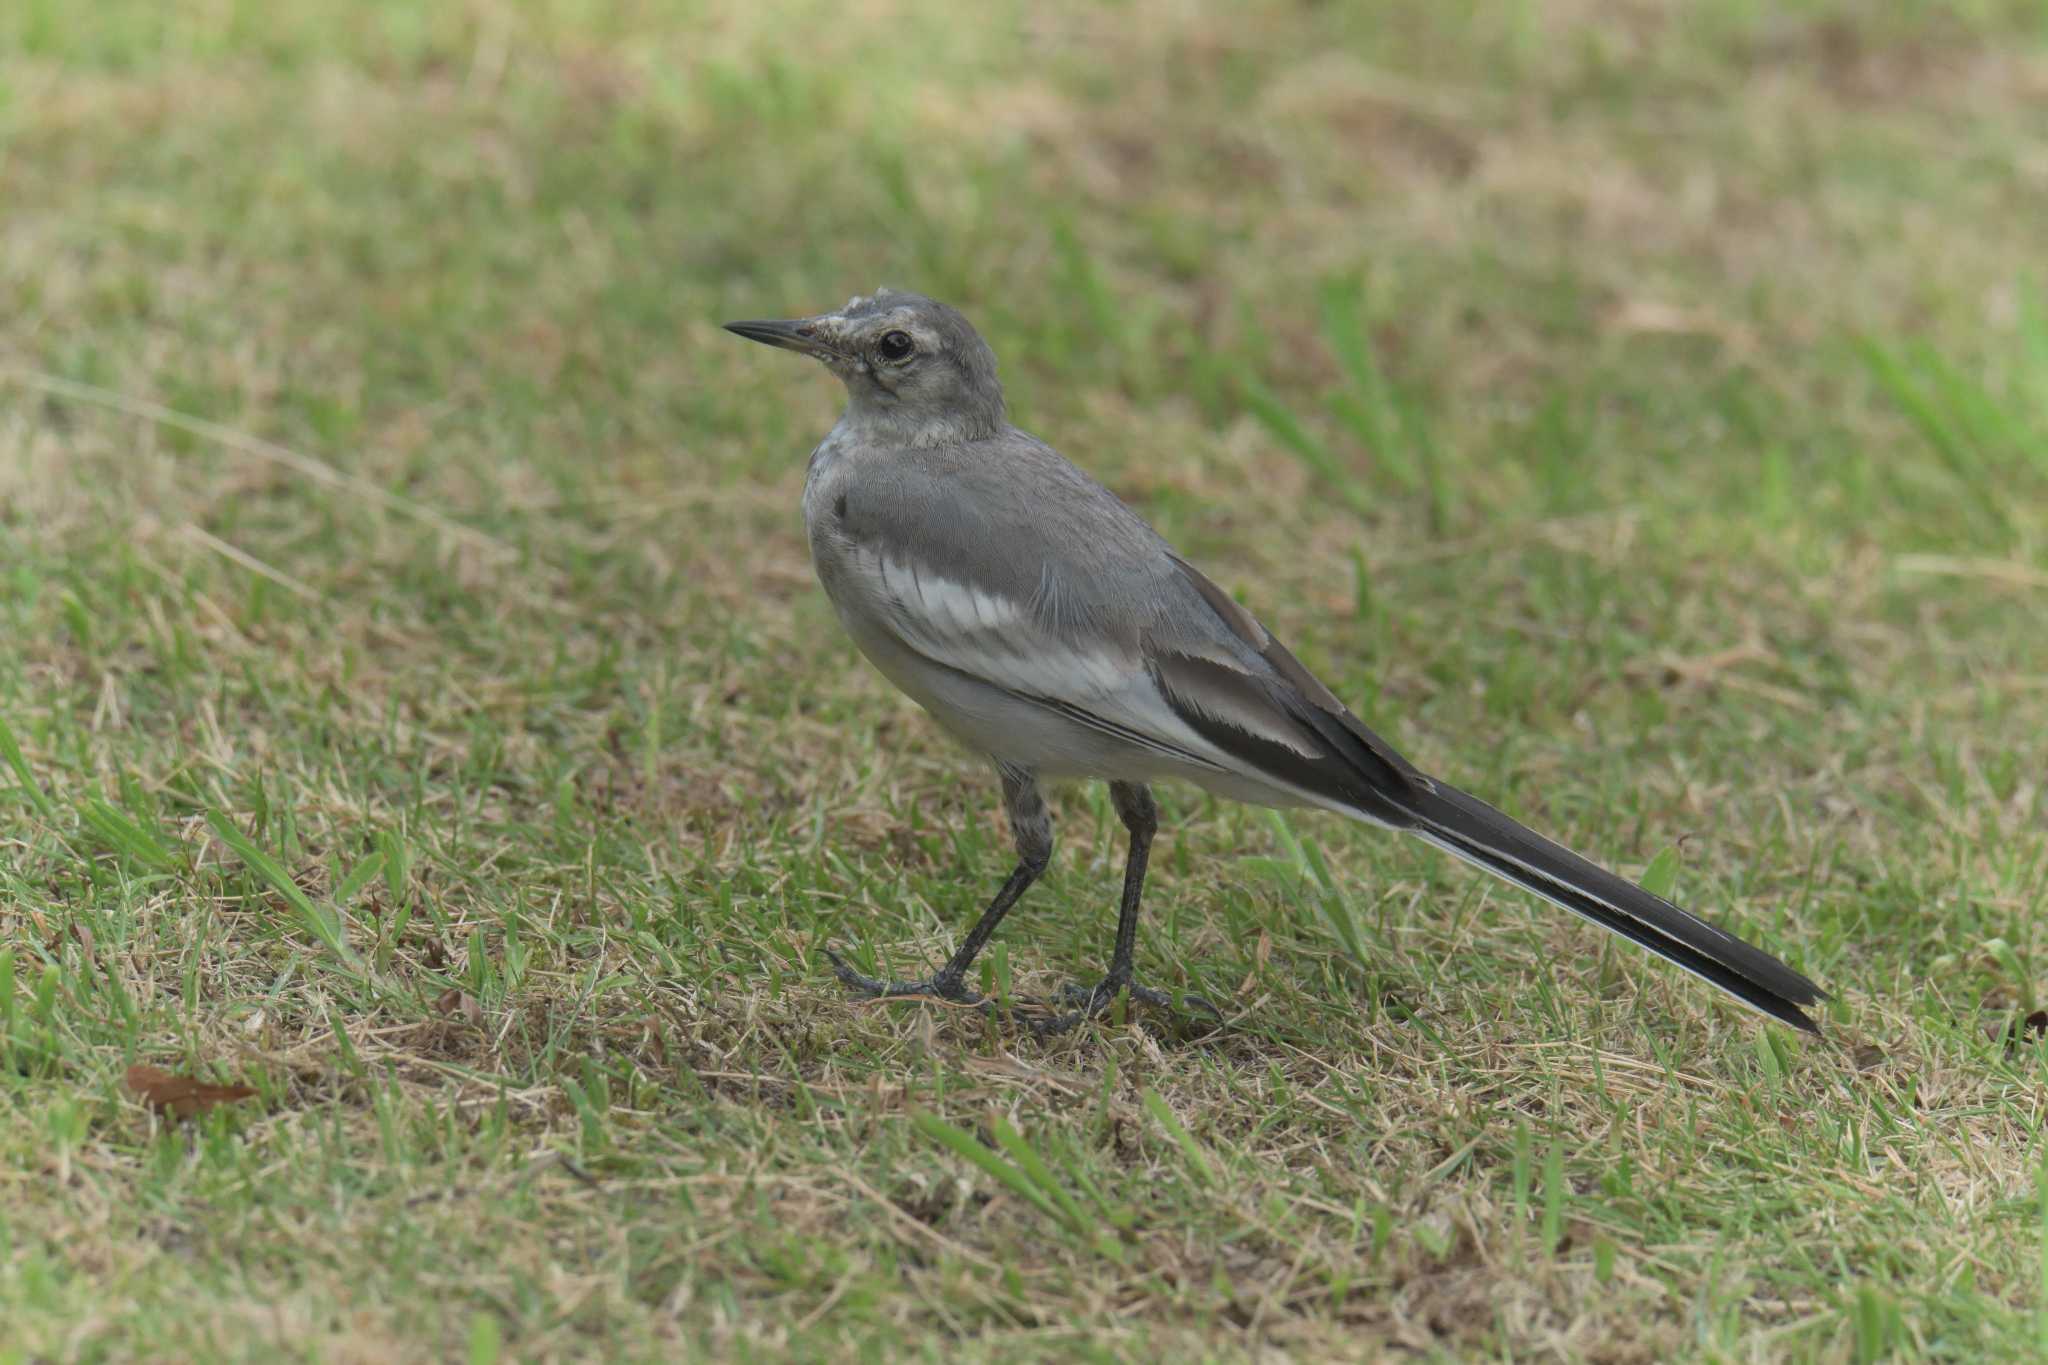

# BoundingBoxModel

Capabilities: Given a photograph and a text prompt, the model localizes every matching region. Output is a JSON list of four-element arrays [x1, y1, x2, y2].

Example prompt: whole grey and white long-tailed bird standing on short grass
[[725, 289, 1829, 1033]]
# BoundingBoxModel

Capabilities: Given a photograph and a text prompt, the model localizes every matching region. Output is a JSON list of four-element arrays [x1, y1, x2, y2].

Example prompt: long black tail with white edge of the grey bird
[[1393, 780, 1827, 1033]]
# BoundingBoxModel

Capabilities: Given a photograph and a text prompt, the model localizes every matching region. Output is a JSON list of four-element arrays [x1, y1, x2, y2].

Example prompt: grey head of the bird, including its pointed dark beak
[[725, 289, 1004, 446]]
